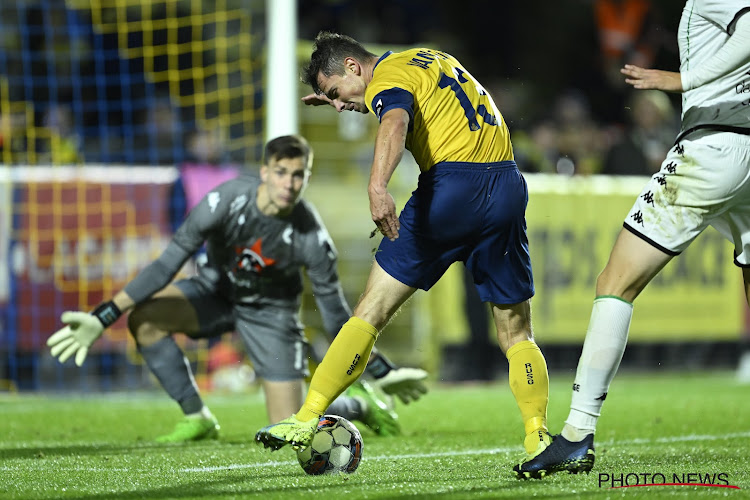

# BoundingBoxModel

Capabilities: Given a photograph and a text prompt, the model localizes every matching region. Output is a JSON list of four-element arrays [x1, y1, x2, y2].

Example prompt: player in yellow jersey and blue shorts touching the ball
[[256, 32, 550, 457]]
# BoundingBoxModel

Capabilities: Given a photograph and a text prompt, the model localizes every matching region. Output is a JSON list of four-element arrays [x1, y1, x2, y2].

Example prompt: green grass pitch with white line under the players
[[0, 372, 750, 500]]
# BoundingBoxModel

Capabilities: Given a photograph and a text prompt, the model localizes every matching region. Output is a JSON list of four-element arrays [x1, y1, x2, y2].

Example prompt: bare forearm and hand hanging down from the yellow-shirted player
[[367, 108, 409, 240]]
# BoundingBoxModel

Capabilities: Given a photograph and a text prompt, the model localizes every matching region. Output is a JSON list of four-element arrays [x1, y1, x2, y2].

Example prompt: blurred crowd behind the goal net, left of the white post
[[0, 0, 265, 165]]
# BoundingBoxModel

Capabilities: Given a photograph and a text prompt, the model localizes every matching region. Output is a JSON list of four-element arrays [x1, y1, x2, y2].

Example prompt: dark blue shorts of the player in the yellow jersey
[[375, 161, 534, 304]]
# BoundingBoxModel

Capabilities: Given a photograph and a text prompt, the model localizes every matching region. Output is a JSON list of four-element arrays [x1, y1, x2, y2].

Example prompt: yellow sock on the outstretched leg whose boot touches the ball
[[297, 316, 378, 422]]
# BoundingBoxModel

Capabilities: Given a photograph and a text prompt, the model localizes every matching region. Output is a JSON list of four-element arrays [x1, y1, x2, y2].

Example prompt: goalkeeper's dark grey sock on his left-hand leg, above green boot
[[138, 336, 203, 415]]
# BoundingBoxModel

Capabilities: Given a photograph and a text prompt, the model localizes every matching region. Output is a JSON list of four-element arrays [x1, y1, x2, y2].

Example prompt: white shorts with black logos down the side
[[624, 131, 750, 267]]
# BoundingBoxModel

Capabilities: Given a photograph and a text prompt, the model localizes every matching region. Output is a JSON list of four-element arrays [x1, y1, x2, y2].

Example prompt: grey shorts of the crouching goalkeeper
[[174, 276, 310, 382]]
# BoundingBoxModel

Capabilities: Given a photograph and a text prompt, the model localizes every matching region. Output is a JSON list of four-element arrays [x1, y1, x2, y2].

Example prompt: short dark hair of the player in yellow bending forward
[[300, 31, 377, 94]]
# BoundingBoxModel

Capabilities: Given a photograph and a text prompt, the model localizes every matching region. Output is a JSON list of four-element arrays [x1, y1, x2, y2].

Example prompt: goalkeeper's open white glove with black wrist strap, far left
[[47, 301, 122, 366]]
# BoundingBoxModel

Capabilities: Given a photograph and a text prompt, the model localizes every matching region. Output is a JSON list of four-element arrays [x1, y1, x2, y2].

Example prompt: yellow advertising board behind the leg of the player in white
[[526, 175, 746, 343]]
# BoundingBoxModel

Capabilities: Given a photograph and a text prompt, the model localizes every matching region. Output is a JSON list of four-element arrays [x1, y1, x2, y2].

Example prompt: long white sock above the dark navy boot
[[562, 296, 633, 441]]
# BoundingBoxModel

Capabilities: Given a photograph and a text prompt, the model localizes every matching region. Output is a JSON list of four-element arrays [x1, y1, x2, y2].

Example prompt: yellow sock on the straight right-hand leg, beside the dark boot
[[505, 340, 549, 453]]
